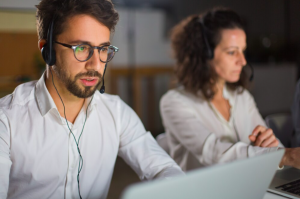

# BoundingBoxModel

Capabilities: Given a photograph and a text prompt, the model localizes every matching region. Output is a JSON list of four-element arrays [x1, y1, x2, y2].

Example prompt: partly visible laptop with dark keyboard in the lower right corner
[[268, 166, 300, 198]]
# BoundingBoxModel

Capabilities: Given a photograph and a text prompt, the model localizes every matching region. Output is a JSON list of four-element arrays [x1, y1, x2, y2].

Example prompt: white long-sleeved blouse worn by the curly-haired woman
[[160, 87, 283, 171]]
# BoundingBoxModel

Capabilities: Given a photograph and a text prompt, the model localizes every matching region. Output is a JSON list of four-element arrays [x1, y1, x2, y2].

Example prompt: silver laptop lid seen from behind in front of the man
[[121, 150, 284, 199]]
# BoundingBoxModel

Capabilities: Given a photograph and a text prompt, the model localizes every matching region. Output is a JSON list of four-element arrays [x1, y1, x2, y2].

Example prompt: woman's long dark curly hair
[[171, 8, 248, 99]]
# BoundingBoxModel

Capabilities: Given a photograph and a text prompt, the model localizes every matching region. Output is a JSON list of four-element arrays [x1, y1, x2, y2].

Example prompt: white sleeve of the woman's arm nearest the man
[[160, 93, 277, 166]]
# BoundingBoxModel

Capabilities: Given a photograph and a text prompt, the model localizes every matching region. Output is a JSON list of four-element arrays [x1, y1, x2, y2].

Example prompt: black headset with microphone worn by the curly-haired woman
[[198, 17, 254, 82]]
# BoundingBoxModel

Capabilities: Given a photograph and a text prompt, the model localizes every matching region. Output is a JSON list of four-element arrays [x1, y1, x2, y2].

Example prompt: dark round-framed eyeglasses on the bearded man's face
[[55, 41, 119, 63]]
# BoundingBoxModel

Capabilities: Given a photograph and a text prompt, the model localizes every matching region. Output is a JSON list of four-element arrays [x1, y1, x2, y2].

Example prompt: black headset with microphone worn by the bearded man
[[41, 17, 107, 94]]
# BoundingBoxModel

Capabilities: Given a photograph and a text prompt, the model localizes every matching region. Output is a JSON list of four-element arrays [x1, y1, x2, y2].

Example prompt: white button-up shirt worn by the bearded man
[[0, 76, 183, 199]]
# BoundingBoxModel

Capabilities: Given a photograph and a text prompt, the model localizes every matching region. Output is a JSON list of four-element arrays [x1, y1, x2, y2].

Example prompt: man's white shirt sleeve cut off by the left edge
[[0, 109, 12, 198]]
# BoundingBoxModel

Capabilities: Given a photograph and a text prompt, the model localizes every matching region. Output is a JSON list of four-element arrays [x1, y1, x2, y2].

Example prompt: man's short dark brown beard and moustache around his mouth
[[53, 66, 102, 98]]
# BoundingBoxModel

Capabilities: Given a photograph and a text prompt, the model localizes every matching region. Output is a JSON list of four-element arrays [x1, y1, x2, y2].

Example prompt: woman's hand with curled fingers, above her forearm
[[249, 125, 279, 147]]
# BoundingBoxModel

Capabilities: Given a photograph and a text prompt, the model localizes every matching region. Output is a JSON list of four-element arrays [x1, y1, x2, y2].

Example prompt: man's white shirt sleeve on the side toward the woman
[[118, 100, 184, 180]]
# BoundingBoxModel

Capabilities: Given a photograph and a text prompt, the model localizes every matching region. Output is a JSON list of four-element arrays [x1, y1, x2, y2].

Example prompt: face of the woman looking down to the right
[[210, 28, 247, 83]]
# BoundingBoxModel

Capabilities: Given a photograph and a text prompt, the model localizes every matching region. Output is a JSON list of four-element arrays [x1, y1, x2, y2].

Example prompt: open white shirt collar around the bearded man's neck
[[35, 72, 99, 116]]
